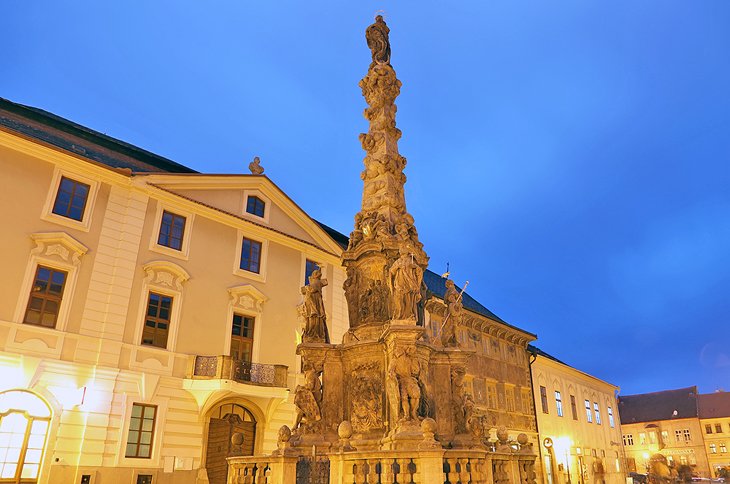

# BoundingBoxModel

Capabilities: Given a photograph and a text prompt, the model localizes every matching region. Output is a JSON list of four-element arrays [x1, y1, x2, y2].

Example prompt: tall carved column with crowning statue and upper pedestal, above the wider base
[[343, 15, 428, 341]]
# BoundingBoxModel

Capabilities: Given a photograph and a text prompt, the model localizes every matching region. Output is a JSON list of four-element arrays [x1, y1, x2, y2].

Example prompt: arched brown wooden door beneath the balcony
[[205, 403, 256, 484]]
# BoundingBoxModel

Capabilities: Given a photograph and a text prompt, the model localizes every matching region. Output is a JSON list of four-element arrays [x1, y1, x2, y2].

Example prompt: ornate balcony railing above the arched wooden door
[[191, 355, 289, 388]]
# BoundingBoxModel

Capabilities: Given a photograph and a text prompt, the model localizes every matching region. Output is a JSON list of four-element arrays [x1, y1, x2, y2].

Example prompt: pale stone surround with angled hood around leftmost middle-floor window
[[13, 232, 88, 331]]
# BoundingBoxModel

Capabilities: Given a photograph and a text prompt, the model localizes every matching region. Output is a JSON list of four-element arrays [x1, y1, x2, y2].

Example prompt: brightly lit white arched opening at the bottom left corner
[[0, 390, 51, 483]]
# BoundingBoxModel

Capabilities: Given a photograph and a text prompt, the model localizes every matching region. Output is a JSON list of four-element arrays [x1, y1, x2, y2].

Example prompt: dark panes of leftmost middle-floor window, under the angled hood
[[23, 265, 68, 328]]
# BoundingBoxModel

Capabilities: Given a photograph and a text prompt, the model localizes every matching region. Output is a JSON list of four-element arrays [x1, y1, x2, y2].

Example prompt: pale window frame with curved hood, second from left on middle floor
[[134, 261, 190, 351]]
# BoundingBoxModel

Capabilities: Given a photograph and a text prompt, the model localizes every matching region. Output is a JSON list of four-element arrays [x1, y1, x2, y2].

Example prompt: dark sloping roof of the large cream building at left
[[0, 98, 196, 173]]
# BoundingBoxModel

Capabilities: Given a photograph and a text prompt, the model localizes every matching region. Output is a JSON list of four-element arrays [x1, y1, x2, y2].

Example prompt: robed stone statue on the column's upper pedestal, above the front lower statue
[[389, 247, 423, 320]]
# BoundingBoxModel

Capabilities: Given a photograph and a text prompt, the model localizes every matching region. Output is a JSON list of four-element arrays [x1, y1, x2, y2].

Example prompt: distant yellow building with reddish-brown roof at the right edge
[[697, 392, 730, 477]]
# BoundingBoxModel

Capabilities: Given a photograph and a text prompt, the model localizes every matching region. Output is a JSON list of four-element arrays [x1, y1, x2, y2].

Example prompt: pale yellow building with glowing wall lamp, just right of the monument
[[530, 346, 626, 484]]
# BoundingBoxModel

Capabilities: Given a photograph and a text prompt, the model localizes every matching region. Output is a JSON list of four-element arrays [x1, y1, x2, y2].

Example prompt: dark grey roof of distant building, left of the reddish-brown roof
[[619, 386, 698, 424]]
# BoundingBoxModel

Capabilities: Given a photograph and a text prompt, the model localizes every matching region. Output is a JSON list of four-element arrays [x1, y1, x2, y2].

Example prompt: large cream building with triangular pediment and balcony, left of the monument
[[0, 100, 348, 483]]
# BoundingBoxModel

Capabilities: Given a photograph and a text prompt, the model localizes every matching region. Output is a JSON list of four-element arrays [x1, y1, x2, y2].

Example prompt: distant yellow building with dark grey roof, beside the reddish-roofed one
[[619, 387, 710, 477]]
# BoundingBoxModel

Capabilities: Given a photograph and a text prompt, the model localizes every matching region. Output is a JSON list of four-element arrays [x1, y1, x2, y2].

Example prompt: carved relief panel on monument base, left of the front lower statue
[[350, 363, 383, 432]]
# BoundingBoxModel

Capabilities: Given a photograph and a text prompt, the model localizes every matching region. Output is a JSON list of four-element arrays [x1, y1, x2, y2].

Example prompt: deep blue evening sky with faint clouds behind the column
[[0, 0, 730, 394]]
